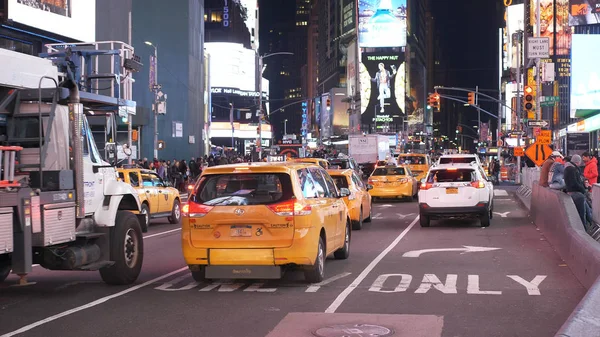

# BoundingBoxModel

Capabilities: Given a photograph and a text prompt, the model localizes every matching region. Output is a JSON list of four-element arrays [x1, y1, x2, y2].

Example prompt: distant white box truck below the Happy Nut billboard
[[348, 134, 391, 164]]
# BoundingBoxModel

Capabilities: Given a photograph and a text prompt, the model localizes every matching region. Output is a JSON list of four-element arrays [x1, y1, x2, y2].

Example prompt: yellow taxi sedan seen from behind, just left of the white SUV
[[368, 165, 418, 199]]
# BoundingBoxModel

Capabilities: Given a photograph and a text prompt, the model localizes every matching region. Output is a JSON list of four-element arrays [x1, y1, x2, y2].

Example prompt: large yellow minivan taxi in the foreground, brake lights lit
[[181, 161, 352, 283]]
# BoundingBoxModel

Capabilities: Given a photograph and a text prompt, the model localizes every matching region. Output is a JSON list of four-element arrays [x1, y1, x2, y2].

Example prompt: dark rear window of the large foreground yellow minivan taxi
[[193, 173, 294, 206]]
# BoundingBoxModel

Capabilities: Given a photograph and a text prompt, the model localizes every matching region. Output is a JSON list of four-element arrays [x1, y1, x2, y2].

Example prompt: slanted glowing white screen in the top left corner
[[8, 0, 96, 42]]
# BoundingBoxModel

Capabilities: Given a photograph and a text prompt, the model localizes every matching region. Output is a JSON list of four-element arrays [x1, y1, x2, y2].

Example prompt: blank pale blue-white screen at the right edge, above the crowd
[[571, 34, 600, 115]]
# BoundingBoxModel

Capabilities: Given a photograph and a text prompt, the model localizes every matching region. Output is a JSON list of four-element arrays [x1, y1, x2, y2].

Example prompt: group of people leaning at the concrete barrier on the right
[[539, 151, 598, 230]]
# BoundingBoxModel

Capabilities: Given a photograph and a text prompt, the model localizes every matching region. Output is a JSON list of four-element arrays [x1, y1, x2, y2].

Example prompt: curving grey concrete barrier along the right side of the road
[[530, 184, 600, 337]]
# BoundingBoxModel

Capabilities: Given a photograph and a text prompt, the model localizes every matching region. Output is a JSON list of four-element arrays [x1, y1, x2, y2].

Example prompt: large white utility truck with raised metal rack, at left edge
[[0, 42, 144, 284]]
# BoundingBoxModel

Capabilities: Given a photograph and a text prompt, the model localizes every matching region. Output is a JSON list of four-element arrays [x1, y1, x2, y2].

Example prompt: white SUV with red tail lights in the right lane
[[419, 163, 494, 227]]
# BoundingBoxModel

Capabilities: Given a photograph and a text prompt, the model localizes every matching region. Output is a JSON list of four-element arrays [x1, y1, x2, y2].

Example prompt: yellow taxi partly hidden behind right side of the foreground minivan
[[327, 169, 373, 230]]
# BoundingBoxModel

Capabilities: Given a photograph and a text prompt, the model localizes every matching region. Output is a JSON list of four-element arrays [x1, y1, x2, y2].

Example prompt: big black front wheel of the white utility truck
[[100, 211, 144, 285]]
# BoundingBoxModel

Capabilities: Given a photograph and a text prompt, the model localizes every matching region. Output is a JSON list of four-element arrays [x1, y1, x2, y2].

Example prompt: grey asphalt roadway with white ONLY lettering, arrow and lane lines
[[0, 190, 585, 337]]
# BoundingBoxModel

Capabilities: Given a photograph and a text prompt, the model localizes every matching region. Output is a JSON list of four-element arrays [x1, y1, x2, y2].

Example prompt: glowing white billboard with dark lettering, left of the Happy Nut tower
[[204, 42, 256, 91]]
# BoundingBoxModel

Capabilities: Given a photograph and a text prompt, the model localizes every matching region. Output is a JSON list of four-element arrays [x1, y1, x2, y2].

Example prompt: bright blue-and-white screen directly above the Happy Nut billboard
[[358, 0, 406, 48]]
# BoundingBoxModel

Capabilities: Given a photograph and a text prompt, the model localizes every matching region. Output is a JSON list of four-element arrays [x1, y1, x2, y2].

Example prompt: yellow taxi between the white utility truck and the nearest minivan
[[117, 168, 181, 232]]
